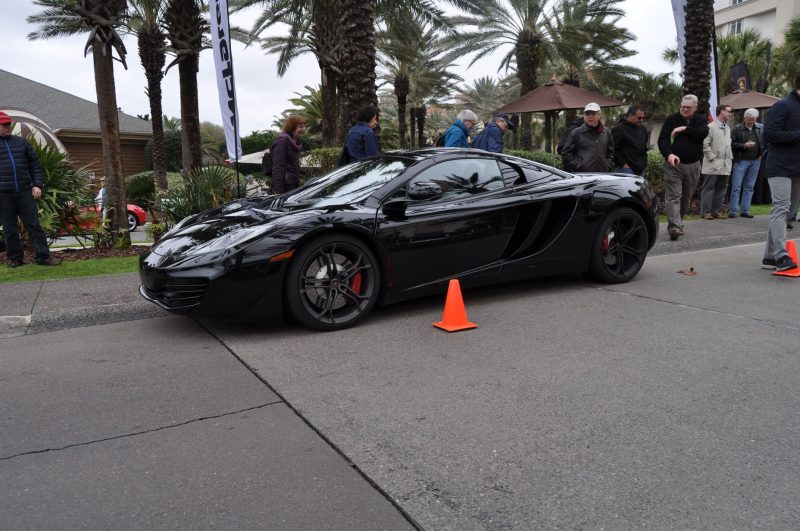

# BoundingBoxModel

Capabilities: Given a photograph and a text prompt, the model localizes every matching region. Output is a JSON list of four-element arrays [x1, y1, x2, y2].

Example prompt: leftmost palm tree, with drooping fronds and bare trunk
[[28, 0, 131, 247]]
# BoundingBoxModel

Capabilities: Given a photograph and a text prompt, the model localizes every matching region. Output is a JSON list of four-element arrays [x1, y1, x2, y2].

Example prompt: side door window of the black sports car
[[408, 159, 504, 200]]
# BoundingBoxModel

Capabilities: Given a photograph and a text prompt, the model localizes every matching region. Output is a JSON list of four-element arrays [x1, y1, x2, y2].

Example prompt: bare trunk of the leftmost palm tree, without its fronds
[[92, 41, 131, 247]]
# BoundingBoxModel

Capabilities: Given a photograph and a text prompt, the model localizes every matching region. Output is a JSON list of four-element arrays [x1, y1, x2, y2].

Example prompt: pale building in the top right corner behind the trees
[[714, 0, 800, 46]]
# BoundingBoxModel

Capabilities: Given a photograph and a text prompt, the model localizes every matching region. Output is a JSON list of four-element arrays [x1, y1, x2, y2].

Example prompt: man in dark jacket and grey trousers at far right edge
[[761, 72, 800, 271]]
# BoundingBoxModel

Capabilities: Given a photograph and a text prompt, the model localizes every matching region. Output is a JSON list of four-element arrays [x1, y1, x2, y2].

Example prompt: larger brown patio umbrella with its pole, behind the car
[[496, 81, 625, 157]]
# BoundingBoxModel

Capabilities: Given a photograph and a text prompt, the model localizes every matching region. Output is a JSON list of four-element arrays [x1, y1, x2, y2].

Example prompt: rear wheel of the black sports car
[[589, 207, 649, 284]]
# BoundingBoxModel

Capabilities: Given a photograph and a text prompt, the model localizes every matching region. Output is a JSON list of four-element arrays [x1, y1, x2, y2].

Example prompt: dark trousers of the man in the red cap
[[0, 190, 50, 262]]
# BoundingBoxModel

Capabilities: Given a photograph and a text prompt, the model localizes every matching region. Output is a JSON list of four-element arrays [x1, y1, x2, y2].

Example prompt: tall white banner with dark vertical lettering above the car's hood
[[208, 0, 242, 160]]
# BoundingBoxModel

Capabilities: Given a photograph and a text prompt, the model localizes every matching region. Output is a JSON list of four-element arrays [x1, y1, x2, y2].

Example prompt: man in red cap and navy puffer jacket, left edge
[[0, 112, 60, 267]]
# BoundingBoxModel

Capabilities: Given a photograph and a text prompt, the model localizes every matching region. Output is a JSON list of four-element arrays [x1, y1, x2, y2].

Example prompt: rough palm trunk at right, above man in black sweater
[[683, 0, 714, 116]]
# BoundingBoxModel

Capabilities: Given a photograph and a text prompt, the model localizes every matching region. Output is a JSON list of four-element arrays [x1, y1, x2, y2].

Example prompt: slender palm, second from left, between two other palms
[[128, 0, 167, 195]]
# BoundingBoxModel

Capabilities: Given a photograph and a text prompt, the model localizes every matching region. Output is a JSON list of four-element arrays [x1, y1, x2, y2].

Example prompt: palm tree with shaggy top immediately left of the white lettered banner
[[164, 0, 208, 172]]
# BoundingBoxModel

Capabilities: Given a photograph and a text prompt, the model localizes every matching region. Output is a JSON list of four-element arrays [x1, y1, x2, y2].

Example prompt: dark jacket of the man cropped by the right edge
[[764, 91, 800, 177]]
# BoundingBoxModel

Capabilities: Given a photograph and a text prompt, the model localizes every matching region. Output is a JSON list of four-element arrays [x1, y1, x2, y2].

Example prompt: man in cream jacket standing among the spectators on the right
[[700, 105, 733, 220]]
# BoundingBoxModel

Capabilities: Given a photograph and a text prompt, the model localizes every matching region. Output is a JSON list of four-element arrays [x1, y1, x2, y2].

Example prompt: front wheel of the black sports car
[[286, 234, 381, 330]]
